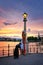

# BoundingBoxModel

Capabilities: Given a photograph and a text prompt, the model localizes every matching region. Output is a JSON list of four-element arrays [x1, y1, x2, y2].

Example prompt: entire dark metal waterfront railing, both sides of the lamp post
[[0, 44, 43, 57]]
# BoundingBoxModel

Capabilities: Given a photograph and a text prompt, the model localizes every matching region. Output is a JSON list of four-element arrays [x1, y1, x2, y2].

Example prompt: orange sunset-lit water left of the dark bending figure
[[0, 41, 19, 56]]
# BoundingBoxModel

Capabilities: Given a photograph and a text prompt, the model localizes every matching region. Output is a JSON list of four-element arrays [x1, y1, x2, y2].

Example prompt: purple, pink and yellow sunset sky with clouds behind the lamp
[[0, 0, 43, 37]]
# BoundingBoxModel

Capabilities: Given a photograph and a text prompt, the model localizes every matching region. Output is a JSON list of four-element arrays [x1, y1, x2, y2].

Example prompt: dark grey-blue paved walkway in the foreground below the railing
[[0, 54, 43, 65]]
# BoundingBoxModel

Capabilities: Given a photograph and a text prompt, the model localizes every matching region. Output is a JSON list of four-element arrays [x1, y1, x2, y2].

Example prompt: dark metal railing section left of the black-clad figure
[[0, 44, 15, 57]]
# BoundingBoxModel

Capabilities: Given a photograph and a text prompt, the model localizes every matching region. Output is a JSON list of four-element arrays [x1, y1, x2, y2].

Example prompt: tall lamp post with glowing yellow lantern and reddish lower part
[[22, 13, 28, 55]]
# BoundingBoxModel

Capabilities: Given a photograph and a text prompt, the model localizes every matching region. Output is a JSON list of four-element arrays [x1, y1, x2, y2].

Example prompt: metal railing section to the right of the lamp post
[[26, 44, 43, 53]]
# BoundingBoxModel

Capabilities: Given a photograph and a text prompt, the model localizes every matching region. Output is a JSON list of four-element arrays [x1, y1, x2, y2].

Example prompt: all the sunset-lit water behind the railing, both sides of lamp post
[[0, 41, 43, 56]]
